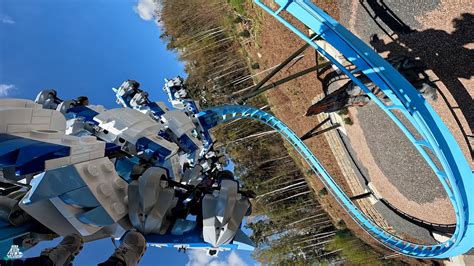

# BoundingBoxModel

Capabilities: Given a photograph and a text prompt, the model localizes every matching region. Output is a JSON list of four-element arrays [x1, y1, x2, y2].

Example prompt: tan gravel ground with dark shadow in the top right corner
[[338, 0, 474, 143]]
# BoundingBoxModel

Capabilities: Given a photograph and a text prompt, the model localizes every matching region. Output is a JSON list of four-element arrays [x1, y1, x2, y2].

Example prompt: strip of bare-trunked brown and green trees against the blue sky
[[158, 0, 388, 265]]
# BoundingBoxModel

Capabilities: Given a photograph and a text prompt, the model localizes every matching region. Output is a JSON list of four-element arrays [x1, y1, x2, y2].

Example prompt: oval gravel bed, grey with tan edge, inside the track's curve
[[345, 106, 455, 224]]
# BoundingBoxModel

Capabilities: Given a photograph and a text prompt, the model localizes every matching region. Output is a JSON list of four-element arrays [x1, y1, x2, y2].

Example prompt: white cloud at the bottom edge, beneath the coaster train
[[186, 250, 247, 266]]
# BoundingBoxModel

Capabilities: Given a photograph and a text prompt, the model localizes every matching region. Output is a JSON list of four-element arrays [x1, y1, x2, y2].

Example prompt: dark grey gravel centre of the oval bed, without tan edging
[[357, 103, 446, 204]]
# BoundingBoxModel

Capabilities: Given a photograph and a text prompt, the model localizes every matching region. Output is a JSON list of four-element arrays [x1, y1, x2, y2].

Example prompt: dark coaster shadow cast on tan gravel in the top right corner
[[360, 0, 474, 157]]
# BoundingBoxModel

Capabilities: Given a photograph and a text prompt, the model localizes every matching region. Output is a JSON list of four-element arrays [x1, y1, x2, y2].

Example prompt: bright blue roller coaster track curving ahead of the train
[[198, 0, 474, 258]]
